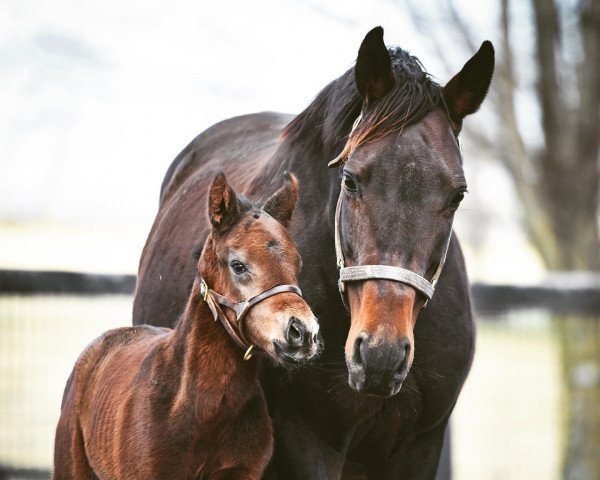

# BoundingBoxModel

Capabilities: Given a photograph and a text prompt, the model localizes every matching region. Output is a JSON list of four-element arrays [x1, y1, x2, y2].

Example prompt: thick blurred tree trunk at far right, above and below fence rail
[[532, 0, 600, 480]]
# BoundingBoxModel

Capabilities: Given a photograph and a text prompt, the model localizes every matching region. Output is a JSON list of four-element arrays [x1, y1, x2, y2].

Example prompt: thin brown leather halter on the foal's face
[[199, 277, 302, 360]]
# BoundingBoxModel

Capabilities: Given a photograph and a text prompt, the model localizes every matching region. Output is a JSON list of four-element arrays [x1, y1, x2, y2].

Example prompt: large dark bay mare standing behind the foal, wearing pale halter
[[134, 27, 494, 480]]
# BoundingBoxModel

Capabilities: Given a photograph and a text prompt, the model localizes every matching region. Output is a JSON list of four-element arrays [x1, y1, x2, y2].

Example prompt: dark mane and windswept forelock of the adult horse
[[283, 47, 442, 157]]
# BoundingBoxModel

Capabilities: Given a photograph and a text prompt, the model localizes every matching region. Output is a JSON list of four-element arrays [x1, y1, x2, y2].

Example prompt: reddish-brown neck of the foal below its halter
[[171, 279, 257, 416]]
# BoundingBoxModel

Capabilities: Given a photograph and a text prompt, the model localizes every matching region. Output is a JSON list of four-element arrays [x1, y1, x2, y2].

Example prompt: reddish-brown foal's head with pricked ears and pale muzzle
[[198, 173, 320, 363]]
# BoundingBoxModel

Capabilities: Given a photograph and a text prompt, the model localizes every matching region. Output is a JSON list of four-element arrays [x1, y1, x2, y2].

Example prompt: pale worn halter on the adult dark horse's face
[[327, 113, 452, 310]]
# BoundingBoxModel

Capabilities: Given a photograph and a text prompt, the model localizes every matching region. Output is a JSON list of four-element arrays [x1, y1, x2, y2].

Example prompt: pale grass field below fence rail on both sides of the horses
[[0, 296, 561, 480]]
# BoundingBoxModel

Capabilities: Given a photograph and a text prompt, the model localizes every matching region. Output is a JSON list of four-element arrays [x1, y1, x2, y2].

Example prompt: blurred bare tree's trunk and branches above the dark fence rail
[[411, 0, 600, 271]]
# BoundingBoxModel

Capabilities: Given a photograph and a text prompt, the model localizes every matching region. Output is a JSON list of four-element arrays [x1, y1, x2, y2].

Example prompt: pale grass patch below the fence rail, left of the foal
[[0, 295, 131, 468]]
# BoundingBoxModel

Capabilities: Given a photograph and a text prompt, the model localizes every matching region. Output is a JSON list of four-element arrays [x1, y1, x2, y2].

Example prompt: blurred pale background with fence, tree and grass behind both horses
[[0, 0, 600, 480]]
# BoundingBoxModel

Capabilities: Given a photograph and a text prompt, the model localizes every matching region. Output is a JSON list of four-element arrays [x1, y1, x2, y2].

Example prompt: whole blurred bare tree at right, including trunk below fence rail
[[410, 0, 600, 474]]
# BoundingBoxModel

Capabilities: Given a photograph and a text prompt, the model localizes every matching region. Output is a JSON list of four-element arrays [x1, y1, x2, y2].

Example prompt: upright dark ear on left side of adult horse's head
[[354, 27, 394, 103]]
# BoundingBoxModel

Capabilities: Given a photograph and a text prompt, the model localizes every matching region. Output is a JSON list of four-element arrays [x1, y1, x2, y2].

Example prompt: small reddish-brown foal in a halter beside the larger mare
[[53, 174, 319, 480]]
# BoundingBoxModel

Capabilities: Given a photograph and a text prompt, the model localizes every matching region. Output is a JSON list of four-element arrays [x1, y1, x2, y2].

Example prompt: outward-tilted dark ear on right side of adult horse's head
[[443, 40, 494, 134]]
